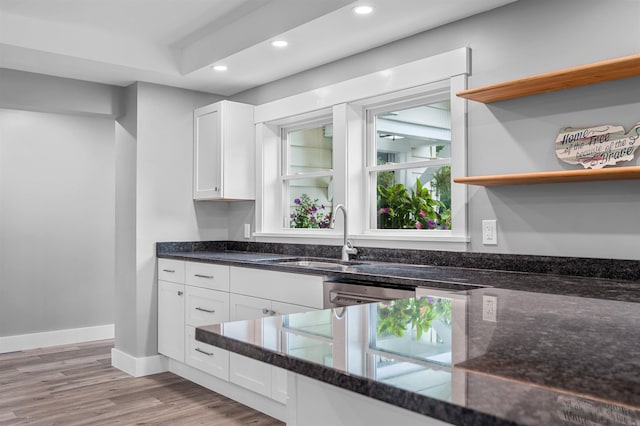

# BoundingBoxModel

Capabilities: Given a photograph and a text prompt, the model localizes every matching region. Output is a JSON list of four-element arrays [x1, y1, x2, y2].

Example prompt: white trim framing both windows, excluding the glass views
[[254, 47, 470, 251]]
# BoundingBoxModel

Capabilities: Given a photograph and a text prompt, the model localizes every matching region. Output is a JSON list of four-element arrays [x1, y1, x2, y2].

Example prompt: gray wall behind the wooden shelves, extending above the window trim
[[230, 0, 640, 259]]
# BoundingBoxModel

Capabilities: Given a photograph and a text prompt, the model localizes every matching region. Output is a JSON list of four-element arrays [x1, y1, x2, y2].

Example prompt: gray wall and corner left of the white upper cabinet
[[115, 83, 228, 357]]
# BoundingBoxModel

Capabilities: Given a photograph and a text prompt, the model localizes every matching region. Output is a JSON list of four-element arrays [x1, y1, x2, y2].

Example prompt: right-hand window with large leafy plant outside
[[366, 96, 451, 231]]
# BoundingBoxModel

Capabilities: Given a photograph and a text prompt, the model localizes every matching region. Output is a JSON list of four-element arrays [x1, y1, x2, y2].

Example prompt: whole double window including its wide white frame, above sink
[[254, 48, 469, 246]]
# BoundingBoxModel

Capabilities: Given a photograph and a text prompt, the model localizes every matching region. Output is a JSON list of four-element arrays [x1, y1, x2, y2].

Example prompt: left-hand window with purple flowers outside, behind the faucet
[[281, 121, 333, 229]]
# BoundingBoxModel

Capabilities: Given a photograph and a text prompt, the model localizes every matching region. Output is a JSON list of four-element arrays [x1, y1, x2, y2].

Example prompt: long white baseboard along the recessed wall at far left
[[0, 324, 115, 354]]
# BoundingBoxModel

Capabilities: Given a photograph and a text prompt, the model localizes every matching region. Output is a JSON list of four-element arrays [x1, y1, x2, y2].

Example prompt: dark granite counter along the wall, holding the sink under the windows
[[157, 243, 640, 302]]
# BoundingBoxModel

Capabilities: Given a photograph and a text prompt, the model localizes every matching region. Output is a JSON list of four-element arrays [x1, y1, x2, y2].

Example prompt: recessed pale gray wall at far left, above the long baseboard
[[0, 109, 114, 340]]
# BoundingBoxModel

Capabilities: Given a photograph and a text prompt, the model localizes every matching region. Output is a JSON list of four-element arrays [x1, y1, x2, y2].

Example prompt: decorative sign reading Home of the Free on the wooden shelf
[[556, 123, 640, 169]]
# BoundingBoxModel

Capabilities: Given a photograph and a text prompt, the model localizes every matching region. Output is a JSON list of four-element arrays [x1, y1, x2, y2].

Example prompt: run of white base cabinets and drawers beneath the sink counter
[[158, 259, 323, 414]]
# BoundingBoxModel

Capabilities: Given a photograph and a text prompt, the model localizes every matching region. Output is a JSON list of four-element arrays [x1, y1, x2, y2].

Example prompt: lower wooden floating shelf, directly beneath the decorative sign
[[453, 166, 640, 186]]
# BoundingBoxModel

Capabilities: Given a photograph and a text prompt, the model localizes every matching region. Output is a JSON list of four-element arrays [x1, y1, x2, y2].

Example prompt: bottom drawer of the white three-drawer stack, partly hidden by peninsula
[[185, 325, 229, 380]]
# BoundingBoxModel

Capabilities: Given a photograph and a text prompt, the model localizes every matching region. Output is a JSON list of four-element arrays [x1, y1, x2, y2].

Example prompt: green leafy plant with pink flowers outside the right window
[[378, 179, 443, 229]]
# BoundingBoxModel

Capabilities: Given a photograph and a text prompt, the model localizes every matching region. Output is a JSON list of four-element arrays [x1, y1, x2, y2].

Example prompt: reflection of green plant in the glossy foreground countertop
[[377, 297, 451, 340]]
